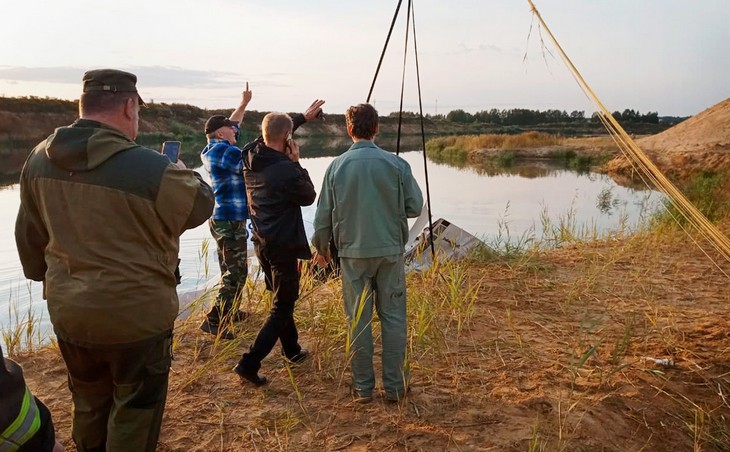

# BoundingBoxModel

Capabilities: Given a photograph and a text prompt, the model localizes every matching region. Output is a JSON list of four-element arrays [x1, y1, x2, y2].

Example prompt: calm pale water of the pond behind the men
[[0, 139, 661, 334]]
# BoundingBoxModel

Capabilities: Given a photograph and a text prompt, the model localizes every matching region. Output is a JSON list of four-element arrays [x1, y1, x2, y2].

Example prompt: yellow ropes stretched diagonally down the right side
[[527, 0, 730, 278]]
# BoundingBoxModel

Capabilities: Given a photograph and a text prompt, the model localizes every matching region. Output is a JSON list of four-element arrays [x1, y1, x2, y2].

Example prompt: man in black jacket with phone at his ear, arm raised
[[234, 100, 324, 386]]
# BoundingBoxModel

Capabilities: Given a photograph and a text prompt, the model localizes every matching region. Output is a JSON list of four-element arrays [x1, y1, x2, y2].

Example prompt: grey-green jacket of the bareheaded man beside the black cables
[[312, 141, 423, 258]]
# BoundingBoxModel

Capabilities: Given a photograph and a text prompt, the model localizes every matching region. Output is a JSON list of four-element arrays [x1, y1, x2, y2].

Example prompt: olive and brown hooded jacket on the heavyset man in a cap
[[15, 119, 214, 346]]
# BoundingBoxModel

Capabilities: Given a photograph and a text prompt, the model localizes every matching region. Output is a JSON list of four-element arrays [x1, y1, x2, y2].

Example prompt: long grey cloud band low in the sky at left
[[0, 66, 288, 89]]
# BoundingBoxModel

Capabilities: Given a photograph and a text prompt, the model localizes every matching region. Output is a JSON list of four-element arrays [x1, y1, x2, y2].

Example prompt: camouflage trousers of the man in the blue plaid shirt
[[208, 218, 248, 325]]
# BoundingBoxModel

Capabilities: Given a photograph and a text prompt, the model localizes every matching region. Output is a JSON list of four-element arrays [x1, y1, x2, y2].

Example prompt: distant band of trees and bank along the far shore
[[0, 96, 686, 142]]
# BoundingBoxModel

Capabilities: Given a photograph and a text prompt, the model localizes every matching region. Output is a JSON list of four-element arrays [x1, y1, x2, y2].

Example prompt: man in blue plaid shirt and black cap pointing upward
[[200, 82, 252, 339]]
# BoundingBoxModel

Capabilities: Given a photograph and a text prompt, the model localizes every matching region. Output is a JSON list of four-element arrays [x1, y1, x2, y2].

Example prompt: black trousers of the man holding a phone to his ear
[[239, 245, 302, 372]]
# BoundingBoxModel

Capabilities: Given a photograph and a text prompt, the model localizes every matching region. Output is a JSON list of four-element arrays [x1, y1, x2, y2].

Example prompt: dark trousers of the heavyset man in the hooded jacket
[[58, 331, 172, 452]]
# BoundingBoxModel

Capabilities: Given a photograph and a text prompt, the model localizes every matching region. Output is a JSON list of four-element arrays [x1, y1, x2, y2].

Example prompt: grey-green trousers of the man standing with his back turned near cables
[[340, 254, 409, 397]]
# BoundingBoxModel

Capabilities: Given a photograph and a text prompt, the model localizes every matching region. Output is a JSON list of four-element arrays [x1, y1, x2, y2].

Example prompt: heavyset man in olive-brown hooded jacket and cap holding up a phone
[[15, 69, 214, 451]]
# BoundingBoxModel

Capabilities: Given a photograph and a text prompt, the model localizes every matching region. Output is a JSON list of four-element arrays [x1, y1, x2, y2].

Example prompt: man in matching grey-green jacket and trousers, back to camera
[[312, 104, 423, 403]]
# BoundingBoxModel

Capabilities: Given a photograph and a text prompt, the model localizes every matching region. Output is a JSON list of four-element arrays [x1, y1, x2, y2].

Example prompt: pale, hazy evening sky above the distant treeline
[[0, 0, 730, 116]]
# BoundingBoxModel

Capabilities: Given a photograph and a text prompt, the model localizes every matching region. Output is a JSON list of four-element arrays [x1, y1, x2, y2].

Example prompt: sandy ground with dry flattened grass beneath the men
[[11, 221, 730, 451]]
